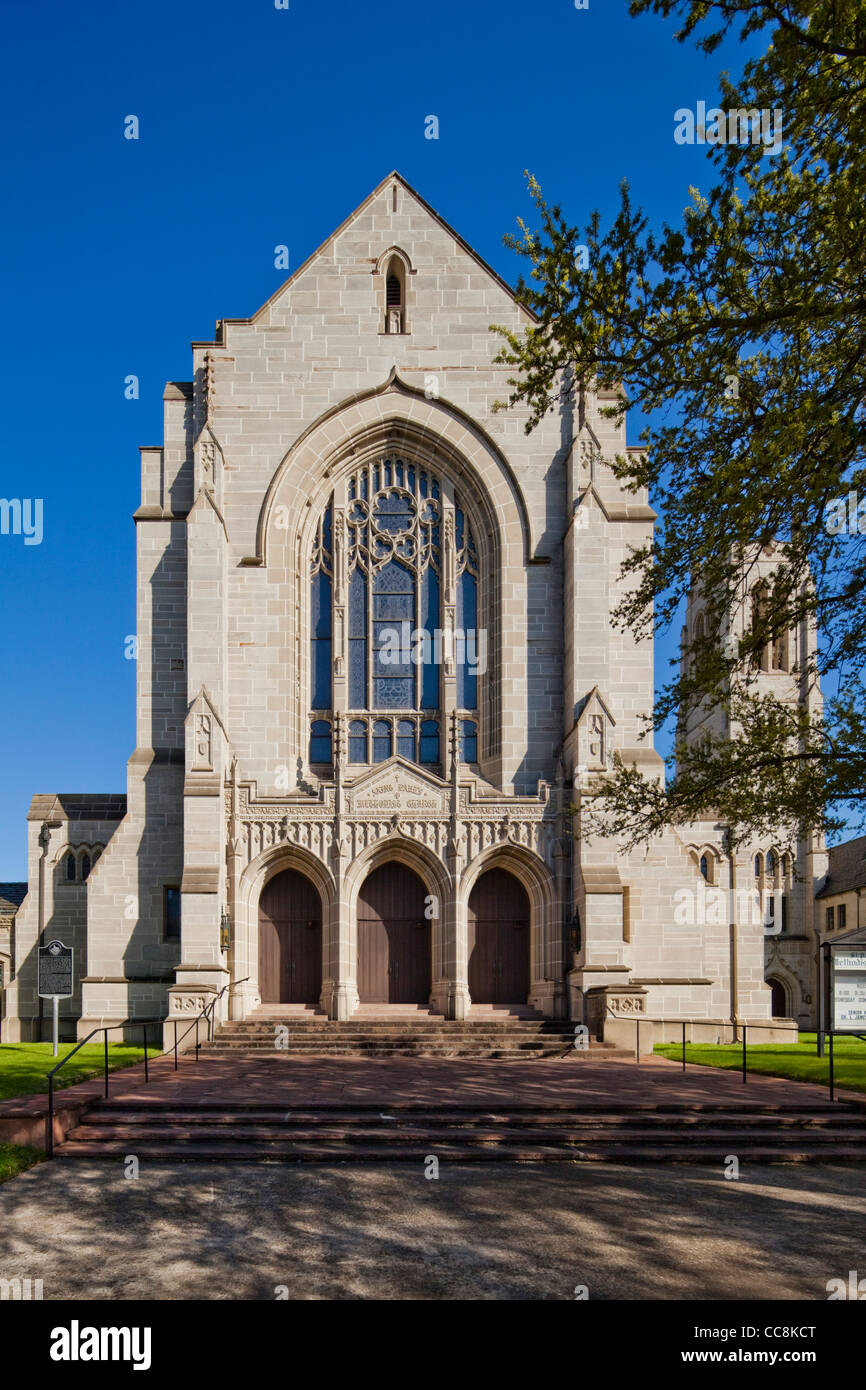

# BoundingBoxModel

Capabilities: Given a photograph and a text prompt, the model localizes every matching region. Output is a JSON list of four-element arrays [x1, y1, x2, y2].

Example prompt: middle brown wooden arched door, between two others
[[357, 863, 431, 1004]]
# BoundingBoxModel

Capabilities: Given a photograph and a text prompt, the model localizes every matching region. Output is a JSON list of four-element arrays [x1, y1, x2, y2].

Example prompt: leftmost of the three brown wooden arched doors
[[259, 869, 321, 1004]]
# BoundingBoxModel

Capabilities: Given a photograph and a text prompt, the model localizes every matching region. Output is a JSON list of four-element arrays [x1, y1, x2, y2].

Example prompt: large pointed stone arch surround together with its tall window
[[247, 373, 530, 785]]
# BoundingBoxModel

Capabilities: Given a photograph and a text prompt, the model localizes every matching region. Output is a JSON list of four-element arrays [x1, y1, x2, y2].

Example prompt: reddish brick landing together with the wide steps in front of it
[[40, 1054, 866, 1165]]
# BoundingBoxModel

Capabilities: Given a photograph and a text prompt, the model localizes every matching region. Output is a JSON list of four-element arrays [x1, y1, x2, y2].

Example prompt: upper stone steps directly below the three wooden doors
[[206, 1005, 594, 1061]]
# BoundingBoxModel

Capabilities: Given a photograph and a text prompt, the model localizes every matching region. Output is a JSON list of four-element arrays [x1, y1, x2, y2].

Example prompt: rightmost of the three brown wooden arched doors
[[468, 869, 530, 1004]]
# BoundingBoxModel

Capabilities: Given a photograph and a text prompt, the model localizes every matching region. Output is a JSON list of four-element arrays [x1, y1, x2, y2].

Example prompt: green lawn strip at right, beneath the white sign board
[[655, 1031, 866, 1093]]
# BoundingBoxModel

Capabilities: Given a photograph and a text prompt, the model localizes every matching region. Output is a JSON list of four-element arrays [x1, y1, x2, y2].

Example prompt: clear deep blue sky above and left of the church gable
[[0, 0, 742, 880]]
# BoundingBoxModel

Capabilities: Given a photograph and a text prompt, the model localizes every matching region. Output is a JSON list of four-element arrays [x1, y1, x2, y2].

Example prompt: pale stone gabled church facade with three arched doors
[[3, 174, 826, 1041]]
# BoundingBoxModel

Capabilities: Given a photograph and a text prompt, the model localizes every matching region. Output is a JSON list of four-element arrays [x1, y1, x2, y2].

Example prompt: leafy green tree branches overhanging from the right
[[496, 0, 866, 844]]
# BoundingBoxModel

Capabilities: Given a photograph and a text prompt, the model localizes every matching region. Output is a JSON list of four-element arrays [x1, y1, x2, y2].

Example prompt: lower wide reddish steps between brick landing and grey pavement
[[56, 1099, 866, 1172]]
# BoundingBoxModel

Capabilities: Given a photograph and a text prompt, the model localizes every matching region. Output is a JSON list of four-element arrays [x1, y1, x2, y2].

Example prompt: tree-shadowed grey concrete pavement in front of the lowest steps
[[0, 1163, 866, 1295]]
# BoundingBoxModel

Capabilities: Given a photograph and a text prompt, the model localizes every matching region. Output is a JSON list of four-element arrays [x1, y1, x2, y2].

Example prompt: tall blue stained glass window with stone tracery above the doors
[[310, 457, 487, 766]]
